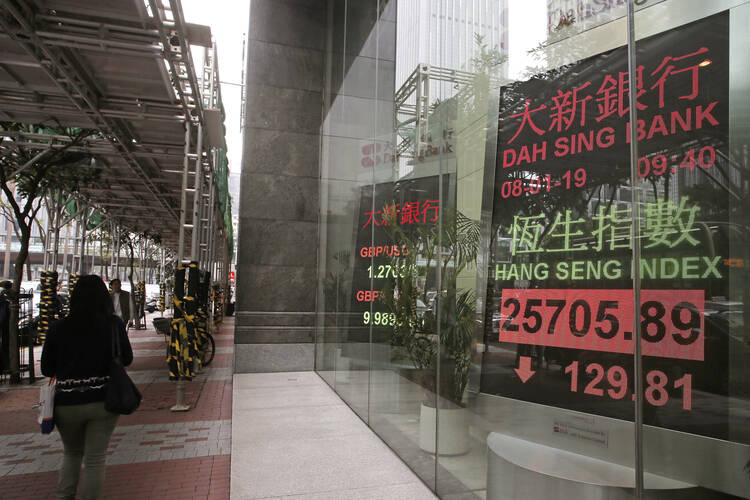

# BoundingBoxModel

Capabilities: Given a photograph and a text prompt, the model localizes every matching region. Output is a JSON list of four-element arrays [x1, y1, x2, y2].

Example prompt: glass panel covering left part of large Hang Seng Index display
[[478, 0, 636, 499]]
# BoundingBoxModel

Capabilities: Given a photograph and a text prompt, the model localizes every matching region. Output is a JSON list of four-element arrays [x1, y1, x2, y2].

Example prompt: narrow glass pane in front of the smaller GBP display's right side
[[364, 1, 440, 489]]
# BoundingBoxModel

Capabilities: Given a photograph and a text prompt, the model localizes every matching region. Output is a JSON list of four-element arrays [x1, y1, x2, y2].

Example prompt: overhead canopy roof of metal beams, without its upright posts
[[0, 0, 231, 248]]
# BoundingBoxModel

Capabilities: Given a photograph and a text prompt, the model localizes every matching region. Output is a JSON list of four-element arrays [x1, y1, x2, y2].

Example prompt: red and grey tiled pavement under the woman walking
[[0, 313, 234, 500]]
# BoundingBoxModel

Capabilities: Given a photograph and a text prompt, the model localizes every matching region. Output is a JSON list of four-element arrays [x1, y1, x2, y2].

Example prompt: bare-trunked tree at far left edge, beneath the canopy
[[0, 122, 101, 383]]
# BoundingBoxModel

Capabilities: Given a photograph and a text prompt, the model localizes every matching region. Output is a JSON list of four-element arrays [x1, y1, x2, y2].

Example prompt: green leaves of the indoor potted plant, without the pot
[[381, 208, 480, 405]]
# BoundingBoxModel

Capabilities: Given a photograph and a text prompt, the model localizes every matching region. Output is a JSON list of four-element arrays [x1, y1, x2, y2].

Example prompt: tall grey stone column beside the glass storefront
[[235, 0, 326, 372]]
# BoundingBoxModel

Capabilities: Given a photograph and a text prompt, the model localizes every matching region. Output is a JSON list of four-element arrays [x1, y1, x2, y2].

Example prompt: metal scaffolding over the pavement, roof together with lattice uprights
[[0, 0, 231, 390]]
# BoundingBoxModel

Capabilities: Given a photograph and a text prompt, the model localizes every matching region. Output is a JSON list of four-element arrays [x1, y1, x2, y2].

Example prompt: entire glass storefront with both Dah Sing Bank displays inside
[[315, 0, 750, 500]]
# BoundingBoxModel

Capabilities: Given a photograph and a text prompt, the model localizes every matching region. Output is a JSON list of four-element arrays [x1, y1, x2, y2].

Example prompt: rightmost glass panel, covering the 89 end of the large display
[[635, 0, 750, 498]]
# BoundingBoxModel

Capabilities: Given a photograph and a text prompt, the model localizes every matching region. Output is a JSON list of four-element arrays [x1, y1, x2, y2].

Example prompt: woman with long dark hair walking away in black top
[[41, 275, 133, 500]]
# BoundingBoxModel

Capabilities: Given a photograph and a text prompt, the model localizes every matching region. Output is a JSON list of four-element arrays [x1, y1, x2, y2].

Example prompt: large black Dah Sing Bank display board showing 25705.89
[[481, 11, 750, 442]]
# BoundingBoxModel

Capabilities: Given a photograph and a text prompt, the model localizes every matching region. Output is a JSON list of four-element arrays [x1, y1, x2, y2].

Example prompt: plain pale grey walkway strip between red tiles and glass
[[232, 372, 436, 500]]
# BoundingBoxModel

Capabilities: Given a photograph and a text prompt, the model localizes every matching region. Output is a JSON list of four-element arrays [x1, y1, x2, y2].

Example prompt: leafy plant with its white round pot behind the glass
[[381, 208, 479, 455]]
